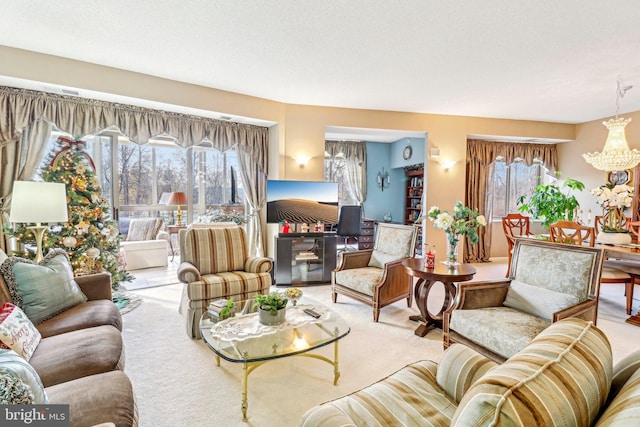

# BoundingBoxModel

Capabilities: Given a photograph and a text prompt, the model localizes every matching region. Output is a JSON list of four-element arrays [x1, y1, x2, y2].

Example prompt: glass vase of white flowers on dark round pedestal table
[[418, 201, 487, 267]]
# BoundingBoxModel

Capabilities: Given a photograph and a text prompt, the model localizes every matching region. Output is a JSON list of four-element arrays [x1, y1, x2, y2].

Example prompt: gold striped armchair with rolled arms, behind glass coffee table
[[178, 227, 273, 338]]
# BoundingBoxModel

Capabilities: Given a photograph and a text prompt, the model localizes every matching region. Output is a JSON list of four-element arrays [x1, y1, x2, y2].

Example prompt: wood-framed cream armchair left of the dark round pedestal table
[[331, 223, 418, 322]]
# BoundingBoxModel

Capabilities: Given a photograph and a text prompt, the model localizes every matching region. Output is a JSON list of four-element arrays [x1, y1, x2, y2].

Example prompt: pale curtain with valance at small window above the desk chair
[[324, 141, 367, 210]]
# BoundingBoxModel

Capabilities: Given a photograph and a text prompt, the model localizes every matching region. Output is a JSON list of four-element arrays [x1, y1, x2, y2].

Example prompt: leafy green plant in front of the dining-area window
[[517, 178, 584, 227]]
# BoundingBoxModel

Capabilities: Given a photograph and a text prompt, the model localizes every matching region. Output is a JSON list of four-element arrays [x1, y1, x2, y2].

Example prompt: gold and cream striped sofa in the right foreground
[[301, 318, 640, 427]]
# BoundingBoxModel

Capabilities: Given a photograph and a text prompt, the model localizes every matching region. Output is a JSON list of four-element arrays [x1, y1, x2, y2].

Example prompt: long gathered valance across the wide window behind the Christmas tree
[[0, 86, 268, 172]]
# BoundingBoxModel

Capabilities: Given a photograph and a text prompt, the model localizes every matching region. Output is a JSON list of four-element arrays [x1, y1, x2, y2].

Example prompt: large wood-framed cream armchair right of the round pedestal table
[[442, 238, 603, 362]]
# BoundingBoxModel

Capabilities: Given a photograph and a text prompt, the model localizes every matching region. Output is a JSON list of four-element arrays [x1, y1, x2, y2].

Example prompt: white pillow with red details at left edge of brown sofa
[[0, 302, 42, 361]]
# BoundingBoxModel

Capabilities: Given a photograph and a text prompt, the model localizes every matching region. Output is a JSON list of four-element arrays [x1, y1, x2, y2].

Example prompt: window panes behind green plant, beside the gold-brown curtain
[[492, 158, 553, 221]]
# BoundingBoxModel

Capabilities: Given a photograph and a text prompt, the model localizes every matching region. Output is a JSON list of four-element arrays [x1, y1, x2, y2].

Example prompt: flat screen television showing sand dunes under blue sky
[[267, 180, 338, 224]]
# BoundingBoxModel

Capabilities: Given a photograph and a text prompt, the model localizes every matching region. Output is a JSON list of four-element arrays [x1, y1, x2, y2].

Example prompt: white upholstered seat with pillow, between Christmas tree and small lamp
[[120, 218, 171, 271]]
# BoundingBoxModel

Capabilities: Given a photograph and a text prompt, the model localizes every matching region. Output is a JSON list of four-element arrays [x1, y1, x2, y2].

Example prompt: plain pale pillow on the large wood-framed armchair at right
[[503, 280, 579, 321]]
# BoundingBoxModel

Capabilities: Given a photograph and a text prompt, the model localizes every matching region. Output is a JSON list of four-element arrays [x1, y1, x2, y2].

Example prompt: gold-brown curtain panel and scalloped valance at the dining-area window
[[464, 139, 558, 262]]
